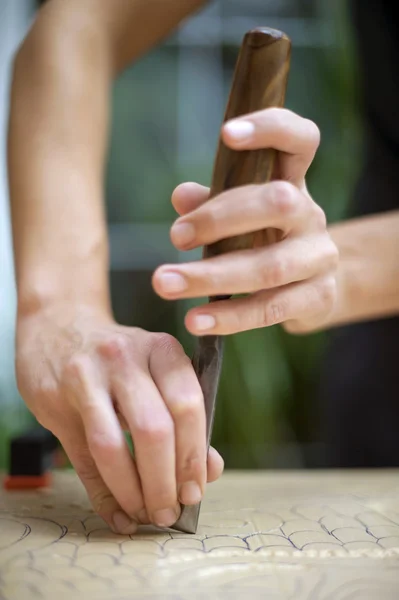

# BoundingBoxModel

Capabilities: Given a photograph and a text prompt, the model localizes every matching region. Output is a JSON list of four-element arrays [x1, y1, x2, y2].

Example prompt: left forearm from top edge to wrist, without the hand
[[9, 0, 208, 315]]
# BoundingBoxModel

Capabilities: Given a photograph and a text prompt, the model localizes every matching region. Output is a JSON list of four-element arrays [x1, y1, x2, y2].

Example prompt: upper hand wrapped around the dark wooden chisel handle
[[153, 108, 338, 335]]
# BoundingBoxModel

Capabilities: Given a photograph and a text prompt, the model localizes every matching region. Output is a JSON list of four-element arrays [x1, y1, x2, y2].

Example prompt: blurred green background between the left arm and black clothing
[[0, 0, 360, 468]]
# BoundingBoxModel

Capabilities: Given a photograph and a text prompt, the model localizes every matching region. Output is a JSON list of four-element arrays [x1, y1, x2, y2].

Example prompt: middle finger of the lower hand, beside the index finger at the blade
[[111, 349, 179, 527]]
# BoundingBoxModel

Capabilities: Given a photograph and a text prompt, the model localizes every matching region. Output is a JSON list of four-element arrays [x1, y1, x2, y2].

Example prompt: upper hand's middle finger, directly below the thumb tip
[[166, 181, 326, 250]]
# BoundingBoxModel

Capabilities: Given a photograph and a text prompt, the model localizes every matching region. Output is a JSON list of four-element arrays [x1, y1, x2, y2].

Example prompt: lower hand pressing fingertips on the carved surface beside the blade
[[17, 306, 223, 534]]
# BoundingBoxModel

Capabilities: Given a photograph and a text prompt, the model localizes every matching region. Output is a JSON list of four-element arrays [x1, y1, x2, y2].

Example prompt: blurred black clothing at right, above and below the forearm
[[319, 0, 399, 467]]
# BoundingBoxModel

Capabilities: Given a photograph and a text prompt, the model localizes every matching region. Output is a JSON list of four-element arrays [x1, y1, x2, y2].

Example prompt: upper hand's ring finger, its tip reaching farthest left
[[154, 234, 338, 299]]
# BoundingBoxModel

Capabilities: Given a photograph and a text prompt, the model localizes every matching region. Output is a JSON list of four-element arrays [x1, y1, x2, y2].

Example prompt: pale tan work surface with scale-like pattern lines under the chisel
[[0, 471, 399, 600]]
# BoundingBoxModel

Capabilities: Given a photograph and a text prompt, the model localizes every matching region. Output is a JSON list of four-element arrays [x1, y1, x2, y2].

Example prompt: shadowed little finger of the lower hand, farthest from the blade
[[57, 419, 137, 535]]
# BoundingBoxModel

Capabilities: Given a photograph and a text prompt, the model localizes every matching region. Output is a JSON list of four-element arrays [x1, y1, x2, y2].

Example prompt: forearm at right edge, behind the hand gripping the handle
[[326, 211, 399, 327]]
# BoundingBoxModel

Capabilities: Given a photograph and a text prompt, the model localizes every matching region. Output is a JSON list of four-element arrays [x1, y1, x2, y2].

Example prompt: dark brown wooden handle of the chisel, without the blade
[[204, 28, 291, 258]]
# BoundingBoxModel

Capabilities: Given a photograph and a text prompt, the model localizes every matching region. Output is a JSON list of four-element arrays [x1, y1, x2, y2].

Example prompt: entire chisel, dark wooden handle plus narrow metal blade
[[172, 28, 291, 533]]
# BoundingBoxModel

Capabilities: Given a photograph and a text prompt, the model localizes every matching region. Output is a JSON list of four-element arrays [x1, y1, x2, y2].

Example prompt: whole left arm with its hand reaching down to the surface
[[9, 0, 222, 534]]
